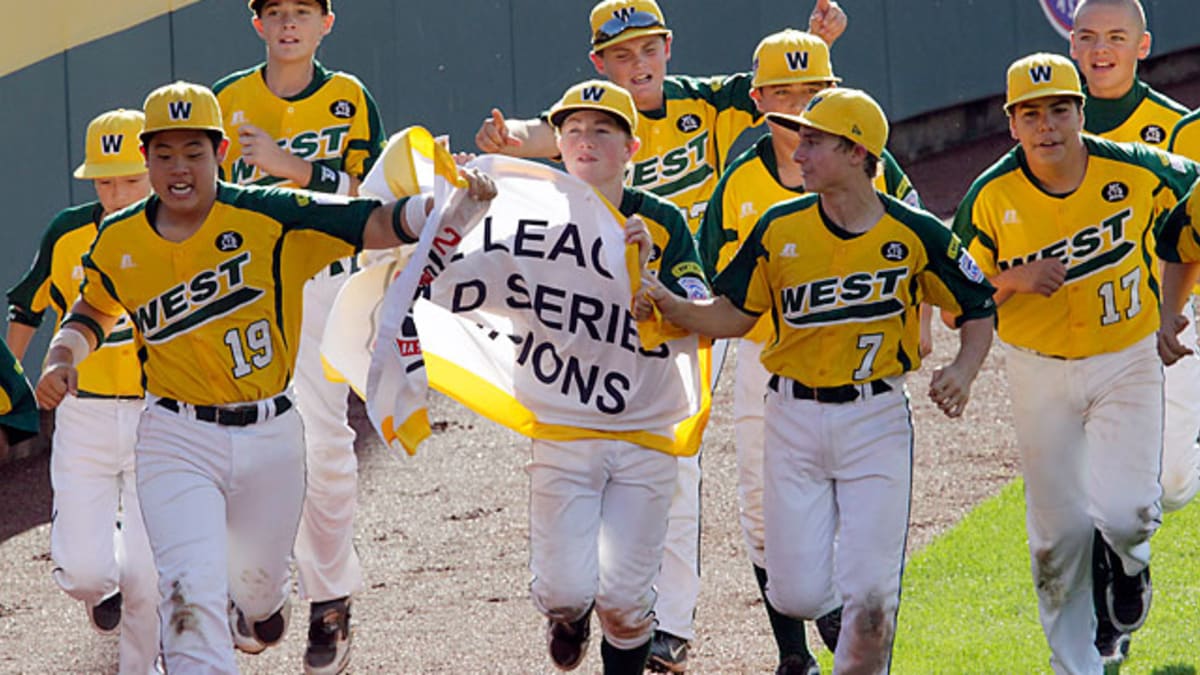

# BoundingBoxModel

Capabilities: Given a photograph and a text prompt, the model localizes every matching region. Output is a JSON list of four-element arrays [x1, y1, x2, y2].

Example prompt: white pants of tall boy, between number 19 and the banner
[[295, 258, 362, 602]]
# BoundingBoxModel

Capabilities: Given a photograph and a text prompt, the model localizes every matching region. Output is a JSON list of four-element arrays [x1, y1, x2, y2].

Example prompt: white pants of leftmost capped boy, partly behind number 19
[[50, 396, 158, 675]]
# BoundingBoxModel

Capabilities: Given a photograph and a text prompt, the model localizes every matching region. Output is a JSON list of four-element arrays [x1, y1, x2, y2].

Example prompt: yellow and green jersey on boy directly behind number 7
[[696, 133, 920, 342]]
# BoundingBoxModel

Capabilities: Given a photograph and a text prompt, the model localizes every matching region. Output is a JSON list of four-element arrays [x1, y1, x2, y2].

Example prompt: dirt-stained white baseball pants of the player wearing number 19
[[137, 396, 305, 675]]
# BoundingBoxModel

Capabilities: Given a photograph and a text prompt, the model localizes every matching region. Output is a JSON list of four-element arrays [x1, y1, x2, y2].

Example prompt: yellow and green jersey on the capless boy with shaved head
[[1084, 79, 1188, 150]]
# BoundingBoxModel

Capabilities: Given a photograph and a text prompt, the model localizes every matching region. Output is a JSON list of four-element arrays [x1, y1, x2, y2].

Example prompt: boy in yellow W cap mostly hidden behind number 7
[[696, 29, 929, 673]]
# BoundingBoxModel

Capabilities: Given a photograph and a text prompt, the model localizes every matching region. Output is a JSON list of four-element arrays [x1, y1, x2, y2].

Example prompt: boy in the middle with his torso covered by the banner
[[528, 80, 708, 675]]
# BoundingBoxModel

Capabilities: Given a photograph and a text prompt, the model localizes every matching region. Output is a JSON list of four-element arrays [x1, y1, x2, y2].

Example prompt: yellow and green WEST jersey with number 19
[[82, 183, 378, 405]]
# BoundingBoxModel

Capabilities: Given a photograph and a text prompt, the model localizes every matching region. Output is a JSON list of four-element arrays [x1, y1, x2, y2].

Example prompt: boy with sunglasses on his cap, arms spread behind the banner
[[475, 0, 846, 673]]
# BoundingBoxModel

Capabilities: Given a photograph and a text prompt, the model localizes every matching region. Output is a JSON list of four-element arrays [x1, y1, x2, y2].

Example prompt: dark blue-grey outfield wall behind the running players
[[0, 0, 1200, 372]]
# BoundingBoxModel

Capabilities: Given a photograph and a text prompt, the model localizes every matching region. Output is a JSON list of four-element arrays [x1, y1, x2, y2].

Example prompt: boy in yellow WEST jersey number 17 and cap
[[954, 54, 1196, 673]]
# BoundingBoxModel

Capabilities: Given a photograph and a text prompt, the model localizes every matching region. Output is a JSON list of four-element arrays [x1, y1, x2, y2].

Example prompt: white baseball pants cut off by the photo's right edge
[[1162, 303, 1200, 513]]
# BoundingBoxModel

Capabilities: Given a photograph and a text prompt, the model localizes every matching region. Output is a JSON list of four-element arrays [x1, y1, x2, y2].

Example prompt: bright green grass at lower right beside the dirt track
[[820, 480, 1200, 675]]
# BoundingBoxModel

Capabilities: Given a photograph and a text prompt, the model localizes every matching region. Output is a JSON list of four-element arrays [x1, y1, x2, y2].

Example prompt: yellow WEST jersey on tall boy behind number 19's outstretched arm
[[212, 62, 388, 192]]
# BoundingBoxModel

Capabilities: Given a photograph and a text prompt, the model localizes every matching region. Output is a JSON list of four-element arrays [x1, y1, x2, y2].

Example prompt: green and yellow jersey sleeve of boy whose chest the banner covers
[[617, 187, 709, 299]]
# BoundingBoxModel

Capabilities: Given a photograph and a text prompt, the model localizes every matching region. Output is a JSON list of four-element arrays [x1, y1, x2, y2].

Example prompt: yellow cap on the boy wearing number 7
[[767, 88, 888, 157]]
